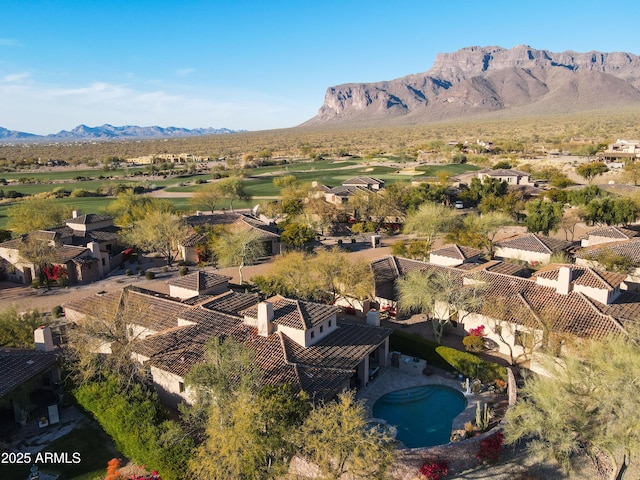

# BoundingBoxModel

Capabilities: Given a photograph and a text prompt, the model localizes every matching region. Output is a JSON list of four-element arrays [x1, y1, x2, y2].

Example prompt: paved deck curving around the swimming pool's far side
[[357, 355, 495, 430]]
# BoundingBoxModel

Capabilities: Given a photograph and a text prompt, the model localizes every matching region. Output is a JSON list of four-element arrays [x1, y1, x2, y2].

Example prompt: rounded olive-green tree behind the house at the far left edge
[[7, 198, 72, 234]]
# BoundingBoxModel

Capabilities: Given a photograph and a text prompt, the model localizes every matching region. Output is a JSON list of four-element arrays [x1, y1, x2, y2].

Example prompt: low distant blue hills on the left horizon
[[0, 124, 244, 142]]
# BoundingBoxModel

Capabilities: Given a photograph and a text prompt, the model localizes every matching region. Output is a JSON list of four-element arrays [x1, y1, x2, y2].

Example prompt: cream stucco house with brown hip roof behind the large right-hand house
[[494, 233, 571, 265]]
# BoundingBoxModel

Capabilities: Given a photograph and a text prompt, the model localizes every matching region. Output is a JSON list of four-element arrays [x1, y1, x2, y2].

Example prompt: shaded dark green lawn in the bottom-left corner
[[0, 421, 122, 480]]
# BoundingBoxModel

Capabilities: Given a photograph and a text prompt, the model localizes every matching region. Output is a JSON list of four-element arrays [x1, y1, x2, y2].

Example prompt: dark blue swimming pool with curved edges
[[373, 385, 467, 448]]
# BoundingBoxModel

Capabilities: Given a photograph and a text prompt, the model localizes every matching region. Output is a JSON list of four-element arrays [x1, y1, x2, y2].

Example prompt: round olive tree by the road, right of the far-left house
[[124, 210, 189, 265]]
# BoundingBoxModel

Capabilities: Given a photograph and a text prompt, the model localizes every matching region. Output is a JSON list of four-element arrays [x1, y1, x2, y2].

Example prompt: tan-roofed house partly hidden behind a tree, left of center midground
[[179, 212, 280, 263]]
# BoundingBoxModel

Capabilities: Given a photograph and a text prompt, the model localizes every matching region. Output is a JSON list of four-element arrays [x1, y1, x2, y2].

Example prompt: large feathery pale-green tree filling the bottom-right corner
[[504, 327, 640, 479]]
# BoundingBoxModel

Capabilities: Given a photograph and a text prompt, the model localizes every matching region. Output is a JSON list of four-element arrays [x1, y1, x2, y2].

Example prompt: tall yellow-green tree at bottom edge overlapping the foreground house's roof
[[183, 338, 310, 480]]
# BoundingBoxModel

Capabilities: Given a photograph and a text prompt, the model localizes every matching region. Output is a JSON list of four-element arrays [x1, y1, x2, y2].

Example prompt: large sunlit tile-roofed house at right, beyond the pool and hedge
[[372, 256, 640, 373]]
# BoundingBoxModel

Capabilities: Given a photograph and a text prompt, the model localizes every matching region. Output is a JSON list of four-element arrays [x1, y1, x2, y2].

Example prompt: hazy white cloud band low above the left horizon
[[0, 79, 315, 134]]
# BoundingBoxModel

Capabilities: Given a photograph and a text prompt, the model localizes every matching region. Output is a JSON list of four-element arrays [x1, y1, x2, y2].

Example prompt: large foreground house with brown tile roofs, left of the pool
[[64, 287, 391, 406]]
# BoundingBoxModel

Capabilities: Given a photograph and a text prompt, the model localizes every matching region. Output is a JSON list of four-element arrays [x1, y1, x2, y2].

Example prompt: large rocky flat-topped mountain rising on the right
[[303, 45, 640, 126]]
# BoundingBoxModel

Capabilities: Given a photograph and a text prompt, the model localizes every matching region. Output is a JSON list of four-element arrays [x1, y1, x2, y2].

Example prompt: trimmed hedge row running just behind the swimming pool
[[389, 330, 507, 383]]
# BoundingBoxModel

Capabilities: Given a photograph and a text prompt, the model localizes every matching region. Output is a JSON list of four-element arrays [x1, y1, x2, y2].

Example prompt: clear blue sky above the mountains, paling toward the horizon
[[0, 0, 640, 134]]
